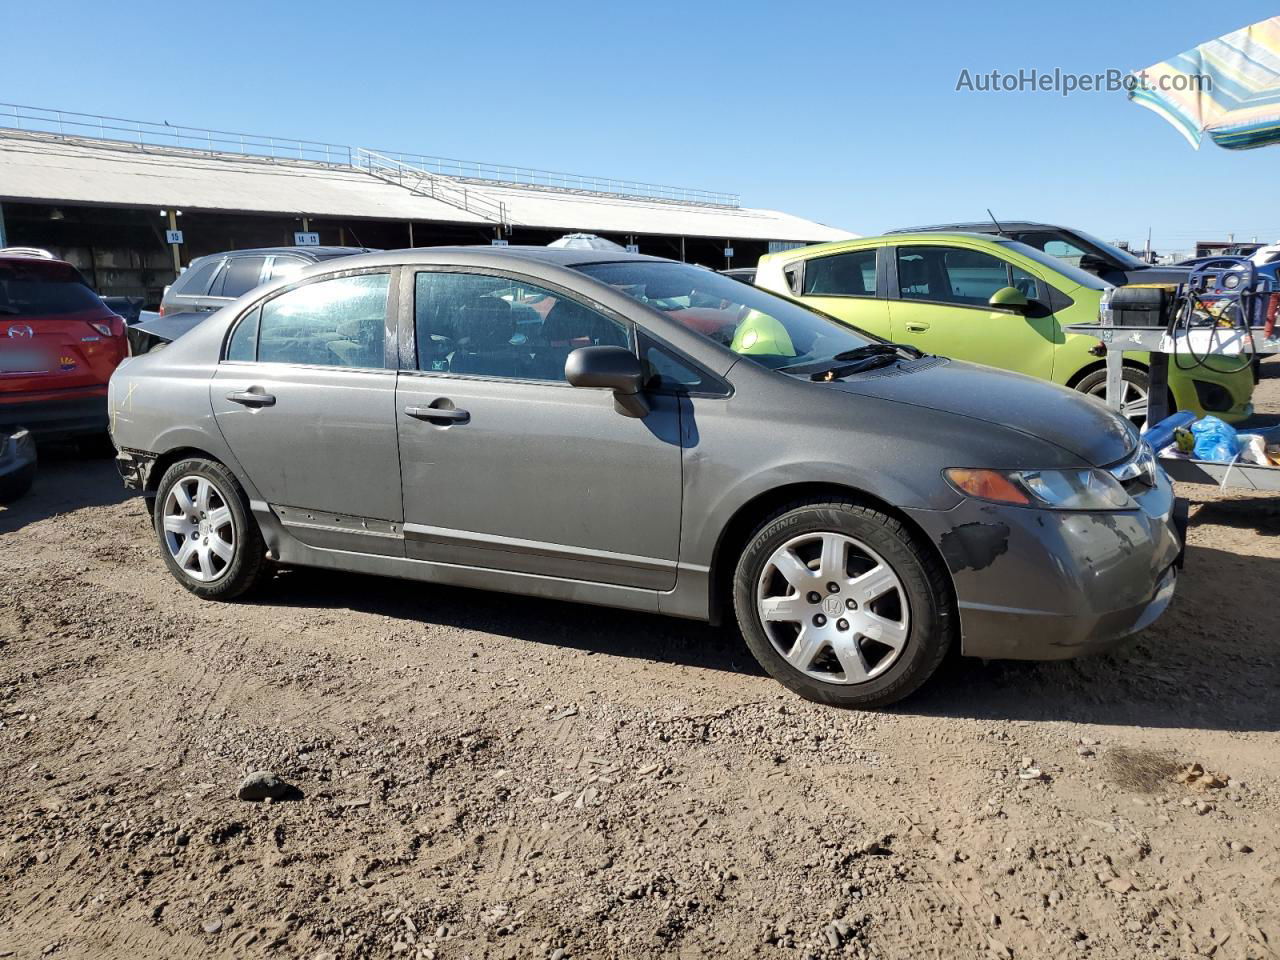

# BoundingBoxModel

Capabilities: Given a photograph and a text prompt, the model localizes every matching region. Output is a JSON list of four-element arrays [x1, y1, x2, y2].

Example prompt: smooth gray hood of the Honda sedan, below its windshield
[[831, 360, 1137, 467]]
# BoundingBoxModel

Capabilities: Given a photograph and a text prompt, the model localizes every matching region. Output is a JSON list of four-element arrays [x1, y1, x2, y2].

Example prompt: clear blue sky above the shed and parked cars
[[0, 0, 1280, 256]]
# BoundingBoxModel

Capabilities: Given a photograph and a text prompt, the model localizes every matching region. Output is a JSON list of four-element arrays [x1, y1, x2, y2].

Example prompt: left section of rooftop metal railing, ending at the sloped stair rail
[[0, 104, 352, 166]]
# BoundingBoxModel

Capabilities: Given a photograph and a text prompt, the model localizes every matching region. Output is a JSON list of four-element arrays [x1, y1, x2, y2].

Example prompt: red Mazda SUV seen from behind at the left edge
[[0, 248, 129, 439]]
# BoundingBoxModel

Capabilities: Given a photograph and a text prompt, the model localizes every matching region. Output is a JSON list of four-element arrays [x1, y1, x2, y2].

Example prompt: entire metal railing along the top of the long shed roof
[[0, 102, 741, 209]]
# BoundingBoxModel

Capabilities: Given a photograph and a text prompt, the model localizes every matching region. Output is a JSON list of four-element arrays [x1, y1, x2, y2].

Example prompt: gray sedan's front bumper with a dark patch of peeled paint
[[908, 470, 1185, 660]]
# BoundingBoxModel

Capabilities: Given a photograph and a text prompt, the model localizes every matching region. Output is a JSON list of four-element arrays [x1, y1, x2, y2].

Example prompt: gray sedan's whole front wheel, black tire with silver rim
[[733, 500, 955, 708]]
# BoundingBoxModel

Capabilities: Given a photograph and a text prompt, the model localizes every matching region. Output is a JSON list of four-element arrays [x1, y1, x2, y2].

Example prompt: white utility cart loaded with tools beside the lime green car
[[1062, 320, 1280, 490]]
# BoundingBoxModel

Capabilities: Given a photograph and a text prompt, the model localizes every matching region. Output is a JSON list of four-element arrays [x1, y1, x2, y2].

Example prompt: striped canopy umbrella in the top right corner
[[1129, 17, 1280, 150]]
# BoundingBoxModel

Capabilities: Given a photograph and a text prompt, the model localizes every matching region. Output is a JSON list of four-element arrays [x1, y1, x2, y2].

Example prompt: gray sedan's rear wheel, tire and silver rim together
[[152, 458, 266, 600]]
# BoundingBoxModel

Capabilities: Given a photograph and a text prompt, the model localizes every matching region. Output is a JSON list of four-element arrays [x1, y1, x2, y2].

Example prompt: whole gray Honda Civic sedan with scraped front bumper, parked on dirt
[[110, 247, 1185, 707]]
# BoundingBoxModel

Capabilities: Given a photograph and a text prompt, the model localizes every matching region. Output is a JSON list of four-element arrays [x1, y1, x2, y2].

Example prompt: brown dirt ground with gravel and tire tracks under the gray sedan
[[0, 361, 1280, 960]]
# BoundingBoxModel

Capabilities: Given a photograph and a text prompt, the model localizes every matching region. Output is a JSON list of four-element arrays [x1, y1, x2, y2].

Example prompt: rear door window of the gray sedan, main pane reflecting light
[[253, 274, 390, 367]]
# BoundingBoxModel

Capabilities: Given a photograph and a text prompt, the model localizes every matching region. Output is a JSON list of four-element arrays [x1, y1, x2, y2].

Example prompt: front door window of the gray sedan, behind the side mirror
[[413, 273, 629, 380]]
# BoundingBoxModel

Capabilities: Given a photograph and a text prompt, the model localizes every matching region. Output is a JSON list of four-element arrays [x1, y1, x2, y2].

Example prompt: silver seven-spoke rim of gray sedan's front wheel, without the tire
[[756, 532, 910, 685]]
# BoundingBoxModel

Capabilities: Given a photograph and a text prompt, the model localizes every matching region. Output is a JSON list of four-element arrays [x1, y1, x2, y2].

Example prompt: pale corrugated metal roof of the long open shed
[[0, 133, 856, 242]]
